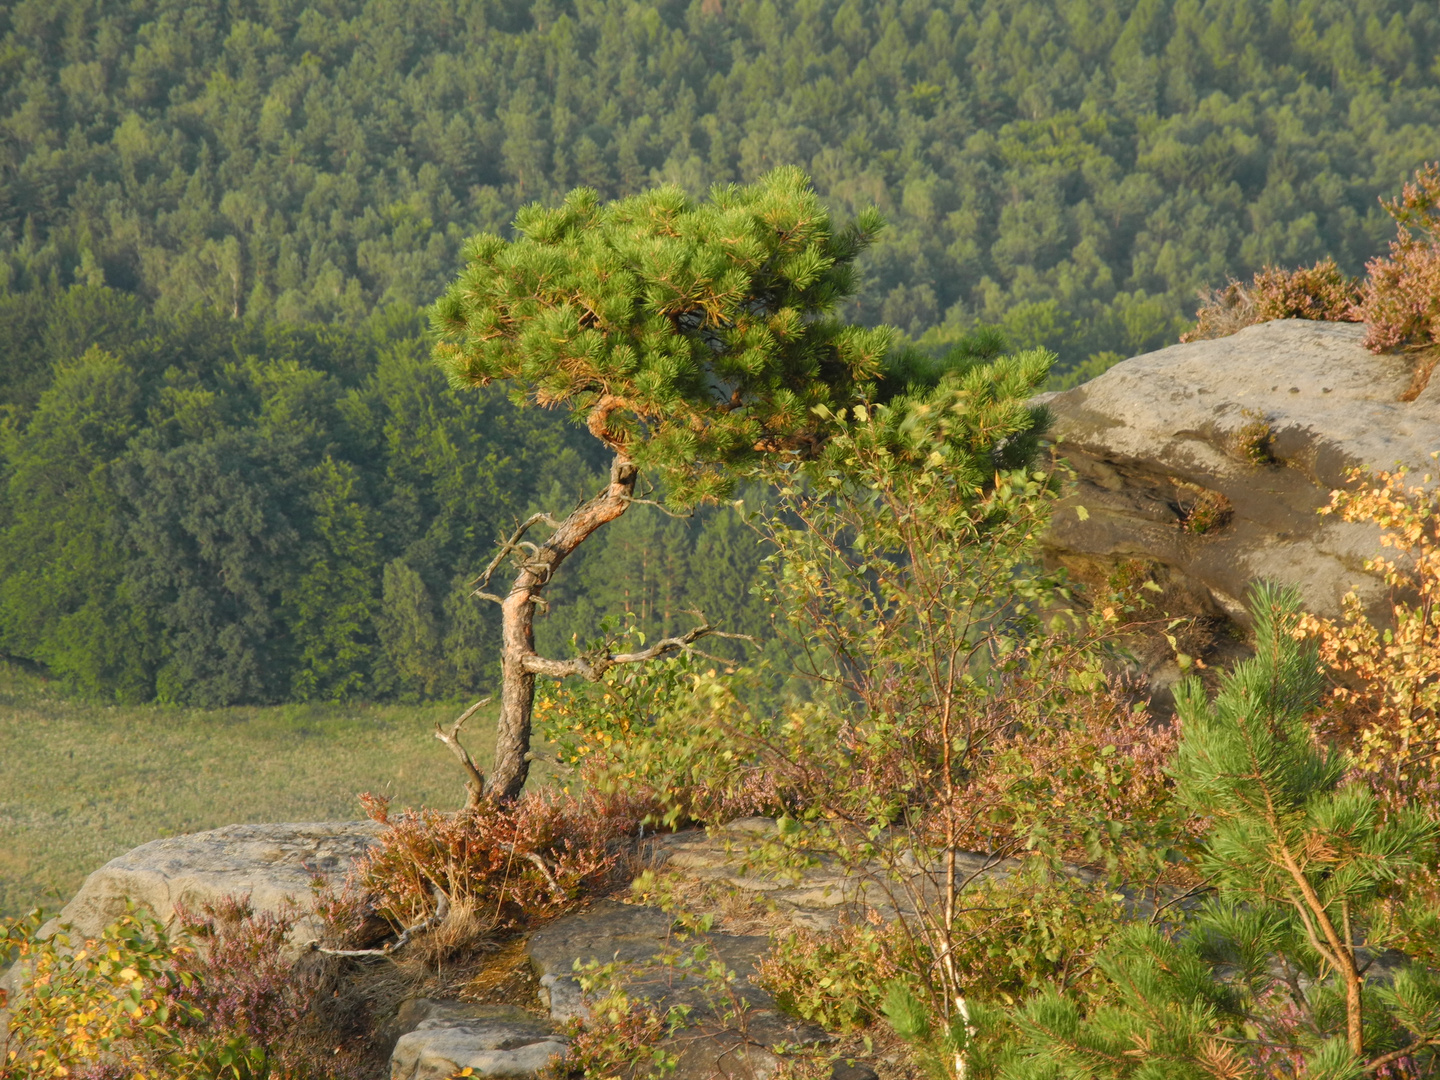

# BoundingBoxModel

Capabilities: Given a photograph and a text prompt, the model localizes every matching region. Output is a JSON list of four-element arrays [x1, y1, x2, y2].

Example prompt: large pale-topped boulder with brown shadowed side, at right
[[1040, 320, 1440, 648]]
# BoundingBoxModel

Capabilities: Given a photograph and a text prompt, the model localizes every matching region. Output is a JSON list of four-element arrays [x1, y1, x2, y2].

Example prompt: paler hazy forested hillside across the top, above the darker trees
[[0, 0, 1440, 367]]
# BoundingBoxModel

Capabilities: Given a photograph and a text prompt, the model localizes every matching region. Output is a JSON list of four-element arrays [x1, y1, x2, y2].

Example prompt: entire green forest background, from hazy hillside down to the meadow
[[0, 0, 1440, 704]]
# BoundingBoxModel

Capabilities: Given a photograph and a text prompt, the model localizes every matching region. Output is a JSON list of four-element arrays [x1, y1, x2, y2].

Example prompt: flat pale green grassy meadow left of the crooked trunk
[[0, 664, 518, 916]]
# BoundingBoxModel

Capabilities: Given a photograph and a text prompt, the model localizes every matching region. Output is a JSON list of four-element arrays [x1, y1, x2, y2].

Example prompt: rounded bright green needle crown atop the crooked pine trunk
[[433, 168, 890, 505]]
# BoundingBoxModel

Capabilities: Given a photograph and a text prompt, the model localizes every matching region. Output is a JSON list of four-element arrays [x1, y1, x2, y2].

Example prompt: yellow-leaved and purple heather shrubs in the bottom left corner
[[0, 900, 342, 1080]]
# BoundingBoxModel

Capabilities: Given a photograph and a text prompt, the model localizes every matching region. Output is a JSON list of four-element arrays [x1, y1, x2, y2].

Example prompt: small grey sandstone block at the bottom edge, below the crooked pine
[[390, 1017, 567, 1080]]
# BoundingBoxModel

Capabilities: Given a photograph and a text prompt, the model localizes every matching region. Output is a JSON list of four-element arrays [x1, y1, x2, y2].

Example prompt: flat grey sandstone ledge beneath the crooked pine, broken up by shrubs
[[8, 818, 933, 1080]]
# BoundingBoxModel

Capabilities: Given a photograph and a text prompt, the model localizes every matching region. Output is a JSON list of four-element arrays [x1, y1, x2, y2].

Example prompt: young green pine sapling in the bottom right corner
[[1004, 588, 1440, 1080]]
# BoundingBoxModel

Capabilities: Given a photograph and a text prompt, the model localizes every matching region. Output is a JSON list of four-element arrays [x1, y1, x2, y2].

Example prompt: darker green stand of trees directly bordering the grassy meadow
[[0, 287, 789, 707]]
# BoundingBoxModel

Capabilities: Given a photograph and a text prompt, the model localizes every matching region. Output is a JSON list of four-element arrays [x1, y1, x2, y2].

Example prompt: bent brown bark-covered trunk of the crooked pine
[[487, 451, 636, 802]]
